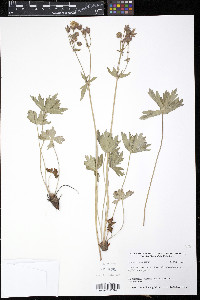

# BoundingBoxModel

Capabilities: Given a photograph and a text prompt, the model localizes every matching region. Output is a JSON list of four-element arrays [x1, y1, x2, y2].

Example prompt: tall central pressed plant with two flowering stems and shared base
[[65, 21, 150, 260]]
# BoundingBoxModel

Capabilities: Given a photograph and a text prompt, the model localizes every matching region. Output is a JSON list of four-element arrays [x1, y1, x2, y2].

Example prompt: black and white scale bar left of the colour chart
[[8, 1, 104, 17]]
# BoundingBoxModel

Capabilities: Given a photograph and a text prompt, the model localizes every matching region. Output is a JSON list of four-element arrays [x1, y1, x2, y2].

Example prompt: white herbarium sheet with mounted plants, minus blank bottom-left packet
[[0, 16, 196, 296]]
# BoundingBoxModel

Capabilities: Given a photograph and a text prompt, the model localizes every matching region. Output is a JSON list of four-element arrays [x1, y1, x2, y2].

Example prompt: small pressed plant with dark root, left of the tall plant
[[27, 94, 67, 209]]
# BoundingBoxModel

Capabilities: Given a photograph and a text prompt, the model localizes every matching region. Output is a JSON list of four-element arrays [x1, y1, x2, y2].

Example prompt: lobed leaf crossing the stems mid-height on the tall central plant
[[97, 130, 119, 153]]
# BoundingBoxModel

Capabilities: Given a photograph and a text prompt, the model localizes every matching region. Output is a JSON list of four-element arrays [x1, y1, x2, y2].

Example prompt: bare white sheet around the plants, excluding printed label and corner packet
[[0, 16, 196, 296]]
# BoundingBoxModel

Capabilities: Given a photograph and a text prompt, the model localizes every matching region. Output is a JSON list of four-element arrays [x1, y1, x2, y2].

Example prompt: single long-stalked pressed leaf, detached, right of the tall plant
[[140, 89, 183, 226]]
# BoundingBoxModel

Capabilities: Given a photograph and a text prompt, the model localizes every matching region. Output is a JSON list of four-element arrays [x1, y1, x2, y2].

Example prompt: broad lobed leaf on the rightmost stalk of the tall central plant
[[121, 132, 150, 153]]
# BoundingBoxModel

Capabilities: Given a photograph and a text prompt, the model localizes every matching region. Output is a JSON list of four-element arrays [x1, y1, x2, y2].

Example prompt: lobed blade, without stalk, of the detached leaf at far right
[[140, 89, 184, 120]]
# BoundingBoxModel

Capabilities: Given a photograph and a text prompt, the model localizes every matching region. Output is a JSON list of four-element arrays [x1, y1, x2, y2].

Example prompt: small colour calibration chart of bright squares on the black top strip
[[108, 0, 134, 16]]
